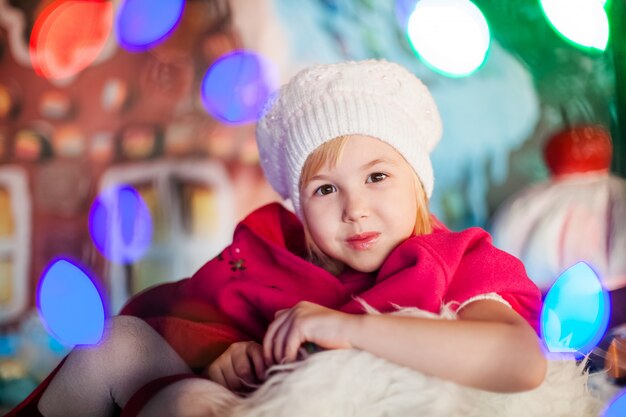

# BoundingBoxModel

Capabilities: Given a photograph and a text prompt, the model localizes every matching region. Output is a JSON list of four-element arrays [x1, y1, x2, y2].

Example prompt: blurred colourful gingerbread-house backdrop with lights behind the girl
[[0, 0, 626, 406]]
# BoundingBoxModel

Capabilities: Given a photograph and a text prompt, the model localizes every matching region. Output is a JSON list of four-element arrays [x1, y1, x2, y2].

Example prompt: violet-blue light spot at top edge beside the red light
[[115, 0, 185, 52]]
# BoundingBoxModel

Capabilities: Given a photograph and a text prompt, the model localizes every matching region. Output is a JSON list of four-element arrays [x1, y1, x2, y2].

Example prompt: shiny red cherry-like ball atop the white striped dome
[[543, 125, 613, 177]]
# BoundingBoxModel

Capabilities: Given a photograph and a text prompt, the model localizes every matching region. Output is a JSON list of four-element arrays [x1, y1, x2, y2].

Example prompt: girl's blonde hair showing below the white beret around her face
[[298, 136, 433, 275]]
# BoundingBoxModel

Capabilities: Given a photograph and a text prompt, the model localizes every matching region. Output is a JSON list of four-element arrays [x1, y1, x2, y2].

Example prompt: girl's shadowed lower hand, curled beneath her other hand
[[206, 341, 267, 392]]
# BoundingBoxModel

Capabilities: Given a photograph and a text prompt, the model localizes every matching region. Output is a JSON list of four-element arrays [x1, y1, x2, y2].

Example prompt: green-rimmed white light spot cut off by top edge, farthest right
[[541, 0, 609, 51]]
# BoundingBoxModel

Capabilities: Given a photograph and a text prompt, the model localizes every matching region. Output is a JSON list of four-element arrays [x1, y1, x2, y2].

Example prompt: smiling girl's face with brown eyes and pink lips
[[300, 135, 417, 272]]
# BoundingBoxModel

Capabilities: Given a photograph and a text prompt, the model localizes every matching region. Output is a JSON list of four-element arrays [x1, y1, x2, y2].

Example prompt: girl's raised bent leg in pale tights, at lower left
[[38, 316, 191, 417]]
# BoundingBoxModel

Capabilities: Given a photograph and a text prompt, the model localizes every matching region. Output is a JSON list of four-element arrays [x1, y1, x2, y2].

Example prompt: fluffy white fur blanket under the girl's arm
[[207, 309, 603, 417]]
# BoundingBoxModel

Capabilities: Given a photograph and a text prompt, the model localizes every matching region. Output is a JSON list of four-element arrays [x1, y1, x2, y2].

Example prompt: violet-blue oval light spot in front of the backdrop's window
[[89, 185, 153, 264]]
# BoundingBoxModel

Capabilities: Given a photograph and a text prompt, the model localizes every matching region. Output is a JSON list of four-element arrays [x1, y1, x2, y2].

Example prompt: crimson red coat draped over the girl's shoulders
[[7, 203, 541, 412]]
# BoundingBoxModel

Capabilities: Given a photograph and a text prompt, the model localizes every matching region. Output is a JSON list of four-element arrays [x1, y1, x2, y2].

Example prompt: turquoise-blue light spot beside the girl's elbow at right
[[541, 262, 610, 358]]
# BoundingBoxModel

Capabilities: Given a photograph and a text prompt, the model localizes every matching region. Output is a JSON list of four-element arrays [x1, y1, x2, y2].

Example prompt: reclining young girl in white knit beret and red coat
[[9, 61, 546, 417]]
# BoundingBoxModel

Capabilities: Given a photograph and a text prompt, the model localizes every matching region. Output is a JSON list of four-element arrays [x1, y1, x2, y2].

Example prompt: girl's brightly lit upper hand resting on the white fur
[[263, 301, 359, 363]]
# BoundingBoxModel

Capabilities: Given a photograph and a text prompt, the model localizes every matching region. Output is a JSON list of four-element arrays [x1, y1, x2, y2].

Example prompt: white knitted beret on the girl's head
[[256, 60, 441, 218]]
